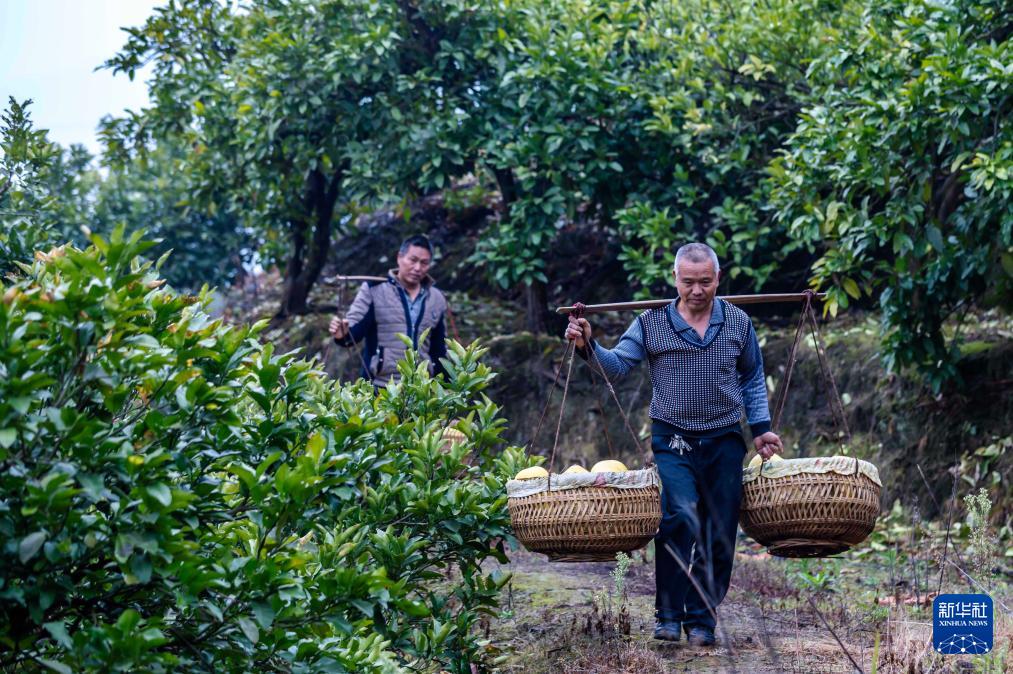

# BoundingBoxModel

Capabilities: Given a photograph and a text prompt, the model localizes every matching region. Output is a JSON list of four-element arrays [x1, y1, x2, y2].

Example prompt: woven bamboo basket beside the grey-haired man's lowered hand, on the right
[[739, 459, 881, 557]]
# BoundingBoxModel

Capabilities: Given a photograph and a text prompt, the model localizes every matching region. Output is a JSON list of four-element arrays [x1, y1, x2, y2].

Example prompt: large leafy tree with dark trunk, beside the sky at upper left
[[105, 0, 506, 315]]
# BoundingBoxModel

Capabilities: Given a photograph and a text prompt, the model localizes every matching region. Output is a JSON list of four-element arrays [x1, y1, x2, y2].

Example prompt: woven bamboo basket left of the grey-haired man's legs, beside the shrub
[[508, 472, 661, 561]]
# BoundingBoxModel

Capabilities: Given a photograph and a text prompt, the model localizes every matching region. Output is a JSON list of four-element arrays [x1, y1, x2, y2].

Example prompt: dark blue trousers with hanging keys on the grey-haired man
[[651, 433, 746, 629]]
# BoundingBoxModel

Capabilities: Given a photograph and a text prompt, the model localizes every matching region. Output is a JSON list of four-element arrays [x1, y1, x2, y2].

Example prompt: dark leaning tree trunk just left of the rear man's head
[[277, 167, 344, 318]]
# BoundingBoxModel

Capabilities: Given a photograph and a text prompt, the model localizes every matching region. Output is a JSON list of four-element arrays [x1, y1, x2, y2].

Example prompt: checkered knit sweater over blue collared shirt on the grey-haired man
[[594, 299, 770, 437]]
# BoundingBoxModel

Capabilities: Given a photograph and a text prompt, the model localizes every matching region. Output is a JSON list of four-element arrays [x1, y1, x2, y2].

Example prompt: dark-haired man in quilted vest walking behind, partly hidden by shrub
[[329, 234, 447, 386]]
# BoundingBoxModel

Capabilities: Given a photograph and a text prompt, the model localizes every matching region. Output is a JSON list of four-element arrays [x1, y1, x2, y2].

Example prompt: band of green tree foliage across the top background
[[0, 0, 1013, 390]]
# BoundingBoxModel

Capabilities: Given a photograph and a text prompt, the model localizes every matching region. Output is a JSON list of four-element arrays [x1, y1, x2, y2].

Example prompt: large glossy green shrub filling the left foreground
[[0, 225, 527, 672]]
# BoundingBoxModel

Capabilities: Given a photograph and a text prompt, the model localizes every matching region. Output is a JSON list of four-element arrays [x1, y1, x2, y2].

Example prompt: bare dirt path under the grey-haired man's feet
[[490, 550, 872, 674]]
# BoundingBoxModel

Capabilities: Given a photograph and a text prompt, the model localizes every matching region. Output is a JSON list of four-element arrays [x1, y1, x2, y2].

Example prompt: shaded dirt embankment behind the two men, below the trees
[[227, 196, 1013, 522]]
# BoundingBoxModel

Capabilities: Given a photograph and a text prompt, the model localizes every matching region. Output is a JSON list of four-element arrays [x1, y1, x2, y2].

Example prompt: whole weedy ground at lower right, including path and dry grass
[[484, 518, 1013, 674]]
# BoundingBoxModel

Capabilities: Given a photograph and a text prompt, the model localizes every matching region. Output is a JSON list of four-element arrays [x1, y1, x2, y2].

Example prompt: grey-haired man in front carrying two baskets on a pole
[[565, 243, 783, 646]]
